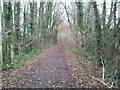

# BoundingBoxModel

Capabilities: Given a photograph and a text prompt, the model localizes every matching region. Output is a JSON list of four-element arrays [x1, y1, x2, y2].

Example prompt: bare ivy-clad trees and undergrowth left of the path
[[2, 1, 60, 69]]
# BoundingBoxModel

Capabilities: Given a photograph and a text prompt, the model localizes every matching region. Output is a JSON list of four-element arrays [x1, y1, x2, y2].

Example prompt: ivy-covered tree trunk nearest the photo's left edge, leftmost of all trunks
[[2, 2, 12, 63]]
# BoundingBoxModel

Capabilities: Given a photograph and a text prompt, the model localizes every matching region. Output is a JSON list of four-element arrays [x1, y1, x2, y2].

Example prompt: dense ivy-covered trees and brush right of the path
[[71, 0, 120, 88]]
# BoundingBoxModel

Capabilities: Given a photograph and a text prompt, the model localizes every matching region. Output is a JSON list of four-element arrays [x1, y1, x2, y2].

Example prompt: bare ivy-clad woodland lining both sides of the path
[[0, 0, 120, 88]]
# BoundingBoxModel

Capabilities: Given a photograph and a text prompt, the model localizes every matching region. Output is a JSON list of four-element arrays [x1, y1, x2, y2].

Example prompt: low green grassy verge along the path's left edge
[[2, 44, 54, 70]]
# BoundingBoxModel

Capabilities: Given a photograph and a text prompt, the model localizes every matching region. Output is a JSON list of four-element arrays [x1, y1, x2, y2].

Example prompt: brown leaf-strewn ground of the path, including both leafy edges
[[2, 44, 103, 88]]
